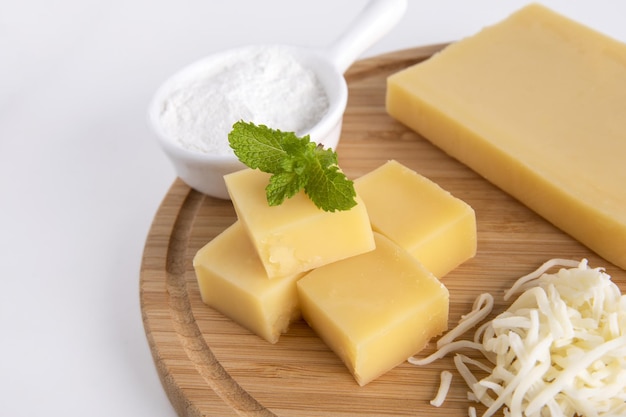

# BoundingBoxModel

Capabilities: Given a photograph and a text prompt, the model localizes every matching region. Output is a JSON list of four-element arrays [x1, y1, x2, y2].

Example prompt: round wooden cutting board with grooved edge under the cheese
[[140, 45, 626, 417]]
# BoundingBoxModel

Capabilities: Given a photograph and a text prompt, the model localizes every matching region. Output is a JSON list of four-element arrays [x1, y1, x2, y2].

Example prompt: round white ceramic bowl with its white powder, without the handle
[[149, 45, 348, 199]]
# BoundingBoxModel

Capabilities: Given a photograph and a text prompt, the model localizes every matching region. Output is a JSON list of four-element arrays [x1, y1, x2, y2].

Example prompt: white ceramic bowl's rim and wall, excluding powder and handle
[[149, 46, 348, 199]]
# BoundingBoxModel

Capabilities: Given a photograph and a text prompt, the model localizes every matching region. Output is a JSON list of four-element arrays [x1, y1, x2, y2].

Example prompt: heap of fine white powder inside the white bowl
[[161, 47, 329, 155]]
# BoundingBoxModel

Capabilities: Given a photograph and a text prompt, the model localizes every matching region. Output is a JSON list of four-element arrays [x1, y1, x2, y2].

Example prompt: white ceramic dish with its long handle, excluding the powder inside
[[149, 0, 407, 199]]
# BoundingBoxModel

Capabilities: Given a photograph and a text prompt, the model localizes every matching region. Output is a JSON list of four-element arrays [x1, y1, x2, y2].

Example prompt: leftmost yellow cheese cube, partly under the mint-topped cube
[[193, 221, 303, 343]]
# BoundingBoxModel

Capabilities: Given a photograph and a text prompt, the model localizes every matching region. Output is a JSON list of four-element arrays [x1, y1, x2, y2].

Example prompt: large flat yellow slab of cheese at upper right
[[386, 4, 626, 268]]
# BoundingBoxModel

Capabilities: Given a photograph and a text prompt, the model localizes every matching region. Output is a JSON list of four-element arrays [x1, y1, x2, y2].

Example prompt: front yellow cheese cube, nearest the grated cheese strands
[[297, 233, 449, 386]]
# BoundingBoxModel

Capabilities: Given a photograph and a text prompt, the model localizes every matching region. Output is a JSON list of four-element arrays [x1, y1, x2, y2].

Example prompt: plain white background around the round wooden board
[[0, 0, 626, 417]]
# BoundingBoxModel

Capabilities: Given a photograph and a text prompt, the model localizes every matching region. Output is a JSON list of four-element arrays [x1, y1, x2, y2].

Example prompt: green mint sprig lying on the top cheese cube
[[228, 121, 356, 212]]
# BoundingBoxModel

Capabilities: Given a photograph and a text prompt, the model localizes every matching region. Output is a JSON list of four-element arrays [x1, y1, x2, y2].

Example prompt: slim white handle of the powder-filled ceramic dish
[[325, 0, 407, 73]]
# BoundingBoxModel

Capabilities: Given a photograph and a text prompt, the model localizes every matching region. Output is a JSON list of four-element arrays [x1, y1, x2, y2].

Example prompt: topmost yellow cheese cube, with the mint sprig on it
[[224, 169, 374, 278]]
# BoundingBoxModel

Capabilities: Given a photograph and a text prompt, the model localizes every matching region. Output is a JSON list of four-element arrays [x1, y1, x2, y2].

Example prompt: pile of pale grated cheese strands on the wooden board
[[409, 259, 626, 417]]
